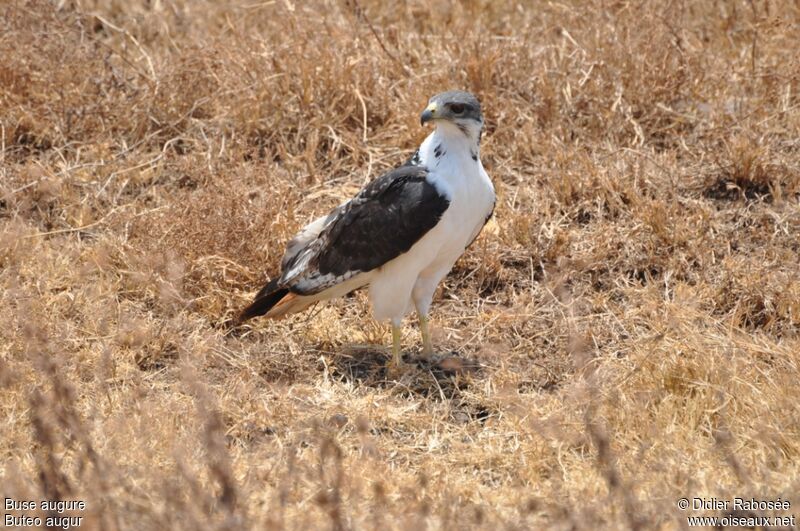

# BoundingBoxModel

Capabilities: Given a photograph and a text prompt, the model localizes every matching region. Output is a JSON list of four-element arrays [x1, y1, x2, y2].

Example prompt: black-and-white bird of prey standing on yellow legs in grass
[[236, 90, 496, 370]]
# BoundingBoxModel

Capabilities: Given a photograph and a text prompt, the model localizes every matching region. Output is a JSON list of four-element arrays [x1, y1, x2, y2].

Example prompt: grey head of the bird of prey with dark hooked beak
[[419, 90, 483, 142]]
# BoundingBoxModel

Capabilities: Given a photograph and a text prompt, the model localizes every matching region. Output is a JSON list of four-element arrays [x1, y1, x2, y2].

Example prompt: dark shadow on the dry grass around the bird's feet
[[318, 345, 482, 399]]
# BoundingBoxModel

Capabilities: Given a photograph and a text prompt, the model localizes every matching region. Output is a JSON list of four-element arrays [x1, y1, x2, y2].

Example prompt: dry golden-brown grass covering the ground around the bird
[[0, 0, 800, 529]]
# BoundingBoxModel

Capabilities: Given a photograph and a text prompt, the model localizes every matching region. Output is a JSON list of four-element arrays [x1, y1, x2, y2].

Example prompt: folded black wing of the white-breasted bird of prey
[[278, 165, 450, 295]]
